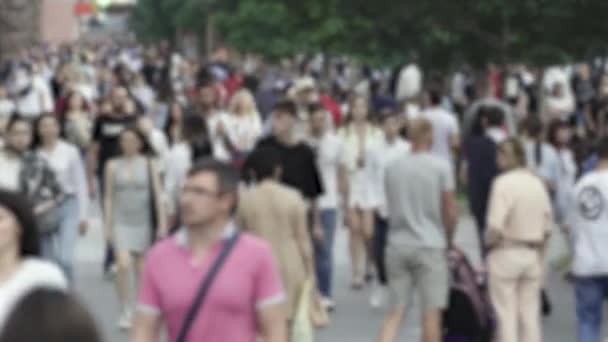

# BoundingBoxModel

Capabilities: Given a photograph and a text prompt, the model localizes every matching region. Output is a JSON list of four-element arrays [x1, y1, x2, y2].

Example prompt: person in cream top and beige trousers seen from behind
[[486, 139, 553, 342]]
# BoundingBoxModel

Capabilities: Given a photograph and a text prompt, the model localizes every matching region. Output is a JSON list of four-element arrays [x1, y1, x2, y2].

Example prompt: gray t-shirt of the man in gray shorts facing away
[[385, 153, 454, 248]]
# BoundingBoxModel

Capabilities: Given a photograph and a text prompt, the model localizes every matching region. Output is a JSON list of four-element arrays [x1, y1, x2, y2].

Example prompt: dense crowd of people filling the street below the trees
[[0, 43, 608, 342]]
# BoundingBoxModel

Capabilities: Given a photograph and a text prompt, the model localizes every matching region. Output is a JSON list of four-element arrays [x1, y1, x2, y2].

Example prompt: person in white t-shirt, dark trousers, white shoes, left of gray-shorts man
[[370, 108, 412, 308]]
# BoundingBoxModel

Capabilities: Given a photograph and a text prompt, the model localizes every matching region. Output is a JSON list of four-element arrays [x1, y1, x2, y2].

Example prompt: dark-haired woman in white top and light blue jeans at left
[[34, 114, 89, 282]]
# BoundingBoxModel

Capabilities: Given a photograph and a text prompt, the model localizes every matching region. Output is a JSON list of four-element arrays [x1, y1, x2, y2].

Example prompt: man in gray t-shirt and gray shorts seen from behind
[[378, 119, 458, 342]]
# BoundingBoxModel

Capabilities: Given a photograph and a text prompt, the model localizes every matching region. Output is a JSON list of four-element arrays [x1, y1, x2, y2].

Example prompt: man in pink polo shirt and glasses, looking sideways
[[133, 160, 287, 342]]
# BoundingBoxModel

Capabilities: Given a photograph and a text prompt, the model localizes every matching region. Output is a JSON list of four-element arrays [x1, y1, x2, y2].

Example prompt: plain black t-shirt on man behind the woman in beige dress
[[258, 136, 324, 199]]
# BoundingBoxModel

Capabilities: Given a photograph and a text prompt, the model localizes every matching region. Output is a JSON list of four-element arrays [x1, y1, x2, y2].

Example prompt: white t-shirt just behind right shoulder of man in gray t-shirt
[[420, 107, 460, 165]]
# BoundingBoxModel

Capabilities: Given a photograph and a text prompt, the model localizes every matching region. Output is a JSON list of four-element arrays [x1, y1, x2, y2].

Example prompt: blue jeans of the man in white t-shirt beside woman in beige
[[314, 209, 337, 298]]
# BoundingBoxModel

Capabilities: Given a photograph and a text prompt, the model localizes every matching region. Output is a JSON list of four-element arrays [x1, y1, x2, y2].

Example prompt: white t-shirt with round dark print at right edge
[[567, 170, 608, 277]]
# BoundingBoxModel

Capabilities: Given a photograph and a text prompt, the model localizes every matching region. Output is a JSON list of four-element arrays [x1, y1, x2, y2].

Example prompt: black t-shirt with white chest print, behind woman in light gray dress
[[93, 115, 137, 174]]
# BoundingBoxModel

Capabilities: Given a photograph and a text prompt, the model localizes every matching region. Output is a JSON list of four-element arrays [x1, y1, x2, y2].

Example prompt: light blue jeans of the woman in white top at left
[[41, 196, 80, 281]]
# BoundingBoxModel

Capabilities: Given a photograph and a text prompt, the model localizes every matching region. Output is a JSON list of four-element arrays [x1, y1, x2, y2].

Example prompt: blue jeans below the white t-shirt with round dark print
[[575, 276, 608, 342]]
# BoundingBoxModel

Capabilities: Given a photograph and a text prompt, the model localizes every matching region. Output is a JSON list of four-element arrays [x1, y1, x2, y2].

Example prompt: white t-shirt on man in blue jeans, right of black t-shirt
[[313, 132, 343, 209]]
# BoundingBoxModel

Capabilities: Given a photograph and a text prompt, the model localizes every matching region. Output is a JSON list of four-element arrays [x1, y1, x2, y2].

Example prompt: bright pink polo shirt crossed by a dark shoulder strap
[[138, 225, 285, 342]]
